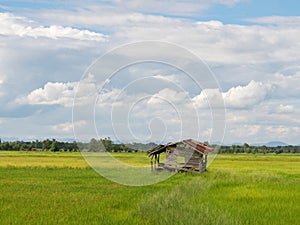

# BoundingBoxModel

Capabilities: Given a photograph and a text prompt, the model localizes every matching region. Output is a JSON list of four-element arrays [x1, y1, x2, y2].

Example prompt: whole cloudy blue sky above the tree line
[[0, 0, 300, 144]]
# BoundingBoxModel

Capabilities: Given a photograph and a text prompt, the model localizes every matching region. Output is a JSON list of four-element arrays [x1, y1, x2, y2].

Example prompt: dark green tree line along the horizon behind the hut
[[0, 138, 300, 154]]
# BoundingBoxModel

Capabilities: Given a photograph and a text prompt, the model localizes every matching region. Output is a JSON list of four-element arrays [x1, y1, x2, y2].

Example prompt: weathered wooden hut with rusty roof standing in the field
[[148, 139, 213, 173]]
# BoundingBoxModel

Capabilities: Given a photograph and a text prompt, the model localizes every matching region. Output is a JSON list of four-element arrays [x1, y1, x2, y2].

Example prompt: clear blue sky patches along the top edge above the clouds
[[0, 0, 300, 23]]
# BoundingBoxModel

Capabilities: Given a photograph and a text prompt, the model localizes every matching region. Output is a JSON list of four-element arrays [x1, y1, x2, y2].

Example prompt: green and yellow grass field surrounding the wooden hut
[[0, 152, 300, 225]]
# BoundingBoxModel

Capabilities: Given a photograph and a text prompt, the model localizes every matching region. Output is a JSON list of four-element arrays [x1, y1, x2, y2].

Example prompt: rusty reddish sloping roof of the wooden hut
[[148, 139, 213, 156]]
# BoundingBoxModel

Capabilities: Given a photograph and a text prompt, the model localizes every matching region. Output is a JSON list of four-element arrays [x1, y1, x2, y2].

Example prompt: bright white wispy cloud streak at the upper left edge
[[0, 13, 106, 42]]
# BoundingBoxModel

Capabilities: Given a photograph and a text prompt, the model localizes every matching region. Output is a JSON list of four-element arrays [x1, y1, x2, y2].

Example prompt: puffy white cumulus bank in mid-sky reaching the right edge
[[193, 73, 300, 109]]
